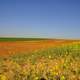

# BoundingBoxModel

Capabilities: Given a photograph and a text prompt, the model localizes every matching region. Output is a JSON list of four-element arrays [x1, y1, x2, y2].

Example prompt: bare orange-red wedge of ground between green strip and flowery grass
[[0, 40, 77, 56]]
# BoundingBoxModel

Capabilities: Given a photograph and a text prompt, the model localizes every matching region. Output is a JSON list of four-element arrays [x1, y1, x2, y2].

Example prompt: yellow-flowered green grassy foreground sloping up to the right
[[0, 43, 80, 80]]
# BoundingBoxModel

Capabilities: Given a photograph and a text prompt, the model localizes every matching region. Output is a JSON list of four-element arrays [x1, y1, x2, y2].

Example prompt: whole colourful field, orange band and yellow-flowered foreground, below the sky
[[0, 39, 80, 80]]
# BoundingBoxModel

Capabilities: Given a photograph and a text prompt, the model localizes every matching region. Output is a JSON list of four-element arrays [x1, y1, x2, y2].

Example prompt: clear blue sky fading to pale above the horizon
[[0, 0, 80, 39]]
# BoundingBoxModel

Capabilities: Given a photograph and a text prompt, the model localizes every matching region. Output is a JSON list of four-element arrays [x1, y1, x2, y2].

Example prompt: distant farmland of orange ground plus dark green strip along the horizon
[[0, 38, 76, 56]]
